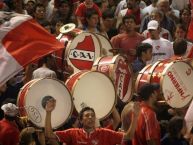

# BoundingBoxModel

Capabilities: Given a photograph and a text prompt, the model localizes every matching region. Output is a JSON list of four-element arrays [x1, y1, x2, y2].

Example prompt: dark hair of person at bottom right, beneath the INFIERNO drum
[[168, 116, 184, 138]]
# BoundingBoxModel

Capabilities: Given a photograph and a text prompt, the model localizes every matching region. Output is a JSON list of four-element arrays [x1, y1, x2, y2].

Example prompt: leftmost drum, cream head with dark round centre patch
[[17, 78, 73, 128]]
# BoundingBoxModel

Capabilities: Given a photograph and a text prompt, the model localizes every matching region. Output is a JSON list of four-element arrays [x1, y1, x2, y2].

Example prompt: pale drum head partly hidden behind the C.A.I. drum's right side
[[96, 33, 113, 56]]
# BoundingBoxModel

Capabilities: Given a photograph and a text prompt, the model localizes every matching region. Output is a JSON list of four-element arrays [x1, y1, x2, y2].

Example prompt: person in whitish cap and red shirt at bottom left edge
[[0, 103, 19, 145]]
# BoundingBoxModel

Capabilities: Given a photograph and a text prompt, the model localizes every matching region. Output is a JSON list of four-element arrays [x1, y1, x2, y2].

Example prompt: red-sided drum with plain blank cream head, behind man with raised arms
[[66, 71, 116, 120]]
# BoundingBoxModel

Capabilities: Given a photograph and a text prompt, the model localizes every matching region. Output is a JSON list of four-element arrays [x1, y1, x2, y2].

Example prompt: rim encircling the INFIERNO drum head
[[160, 60, 193, 109]]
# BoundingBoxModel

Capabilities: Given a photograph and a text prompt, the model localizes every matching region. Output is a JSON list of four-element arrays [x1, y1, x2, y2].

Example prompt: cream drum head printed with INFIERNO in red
[[161, 61, 193, 108]]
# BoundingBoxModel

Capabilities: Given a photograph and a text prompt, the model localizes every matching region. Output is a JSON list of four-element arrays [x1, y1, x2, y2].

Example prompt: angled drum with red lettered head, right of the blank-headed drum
[[92, 55, 133, 102]]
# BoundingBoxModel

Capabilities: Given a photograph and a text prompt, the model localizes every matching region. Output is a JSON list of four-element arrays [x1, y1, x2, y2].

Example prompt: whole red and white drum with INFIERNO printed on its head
[[136, 59, 193, 108]]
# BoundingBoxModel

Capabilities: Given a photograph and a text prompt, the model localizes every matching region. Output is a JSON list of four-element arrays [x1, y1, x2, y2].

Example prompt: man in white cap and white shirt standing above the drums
[[142, 20, 174, 63]]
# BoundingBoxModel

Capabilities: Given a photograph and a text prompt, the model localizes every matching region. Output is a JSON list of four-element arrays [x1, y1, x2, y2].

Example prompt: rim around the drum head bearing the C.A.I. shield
[[66, 31, 102, 72]]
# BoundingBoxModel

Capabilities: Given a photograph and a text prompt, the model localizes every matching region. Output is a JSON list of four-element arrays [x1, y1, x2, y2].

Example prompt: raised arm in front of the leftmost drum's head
[[45, 99, 59, 145]]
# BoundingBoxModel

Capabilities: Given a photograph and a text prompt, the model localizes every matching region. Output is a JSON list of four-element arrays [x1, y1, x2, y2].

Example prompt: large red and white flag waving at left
[[0, 11, 64, 84]]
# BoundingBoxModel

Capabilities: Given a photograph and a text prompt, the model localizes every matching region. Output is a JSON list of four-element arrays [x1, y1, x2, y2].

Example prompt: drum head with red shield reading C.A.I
[[67, 32, 101, 72]]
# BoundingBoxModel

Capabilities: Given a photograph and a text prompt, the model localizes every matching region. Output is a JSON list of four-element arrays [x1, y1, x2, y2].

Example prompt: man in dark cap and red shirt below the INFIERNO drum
[[132, 83, 160, 145]]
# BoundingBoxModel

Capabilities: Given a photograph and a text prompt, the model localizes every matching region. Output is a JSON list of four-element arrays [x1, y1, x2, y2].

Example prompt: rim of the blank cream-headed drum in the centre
[[66, 70, 117, 121]]
